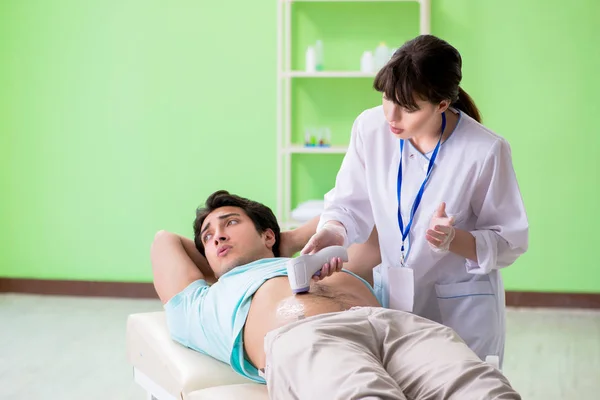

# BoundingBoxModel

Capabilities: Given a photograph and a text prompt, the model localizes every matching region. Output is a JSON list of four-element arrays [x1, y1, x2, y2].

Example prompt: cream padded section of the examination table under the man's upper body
[[127, 311, 266, 399]]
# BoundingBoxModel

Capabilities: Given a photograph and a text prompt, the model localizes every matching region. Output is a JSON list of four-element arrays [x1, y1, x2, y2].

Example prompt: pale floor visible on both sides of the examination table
[[0, 294, 600, 400]]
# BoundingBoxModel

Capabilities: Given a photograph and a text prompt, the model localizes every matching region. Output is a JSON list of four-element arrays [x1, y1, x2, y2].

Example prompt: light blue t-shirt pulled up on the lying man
[[165, 258, 373, 383]]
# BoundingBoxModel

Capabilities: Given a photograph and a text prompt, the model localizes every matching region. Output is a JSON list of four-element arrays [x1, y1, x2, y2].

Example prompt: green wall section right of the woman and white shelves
[[433, 0, 600, 292]]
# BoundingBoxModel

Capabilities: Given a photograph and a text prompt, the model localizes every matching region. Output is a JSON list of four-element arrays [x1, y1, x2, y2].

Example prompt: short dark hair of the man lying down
[[194, 190, 281, 257]]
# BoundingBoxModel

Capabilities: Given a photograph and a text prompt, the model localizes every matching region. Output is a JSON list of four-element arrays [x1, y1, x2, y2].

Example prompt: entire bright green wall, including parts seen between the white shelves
[[0, 0, 600, 292]]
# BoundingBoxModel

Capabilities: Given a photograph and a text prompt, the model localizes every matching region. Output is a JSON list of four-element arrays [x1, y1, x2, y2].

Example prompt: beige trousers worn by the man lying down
[[265, 307, 521, 400]]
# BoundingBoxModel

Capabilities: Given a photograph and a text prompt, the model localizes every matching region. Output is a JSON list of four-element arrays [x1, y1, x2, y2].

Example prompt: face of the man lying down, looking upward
[[200, 206, 275, 278]]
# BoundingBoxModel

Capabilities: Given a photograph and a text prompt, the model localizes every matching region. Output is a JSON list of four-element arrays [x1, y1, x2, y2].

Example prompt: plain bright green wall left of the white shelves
[[0, 0, 276, 281]]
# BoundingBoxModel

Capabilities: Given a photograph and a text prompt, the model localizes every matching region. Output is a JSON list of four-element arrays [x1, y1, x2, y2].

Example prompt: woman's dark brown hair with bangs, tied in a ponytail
[[373, 35, 481, 122]]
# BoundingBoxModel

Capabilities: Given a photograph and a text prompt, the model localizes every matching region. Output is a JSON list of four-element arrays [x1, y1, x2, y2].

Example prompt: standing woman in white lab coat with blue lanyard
[[280, 35, 528, 363]]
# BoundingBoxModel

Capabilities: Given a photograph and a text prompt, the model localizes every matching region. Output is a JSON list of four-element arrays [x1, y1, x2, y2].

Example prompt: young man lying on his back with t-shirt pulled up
[[151, 191, 520, 400]]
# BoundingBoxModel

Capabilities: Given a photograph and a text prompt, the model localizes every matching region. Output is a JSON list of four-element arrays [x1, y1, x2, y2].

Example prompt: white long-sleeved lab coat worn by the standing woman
[[319, 106, 529, 360]]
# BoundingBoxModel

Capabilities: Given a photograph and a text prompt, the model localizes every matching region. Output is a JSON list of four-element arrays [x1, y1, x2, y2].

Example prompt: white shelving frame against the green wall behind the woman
[[276, 0, 431, 230]]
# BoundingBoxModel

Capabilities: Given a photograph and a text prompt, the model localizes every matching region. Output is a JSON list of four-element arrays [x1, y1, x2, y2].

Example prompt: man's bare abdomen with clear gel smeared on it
[[244, 272, 379, 368]]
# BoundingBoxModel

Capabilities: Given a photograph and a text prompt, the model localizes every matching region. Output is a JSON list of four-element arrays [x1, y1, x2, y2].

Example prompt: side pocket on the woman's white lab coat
[[435, 281, 503, 360]]
